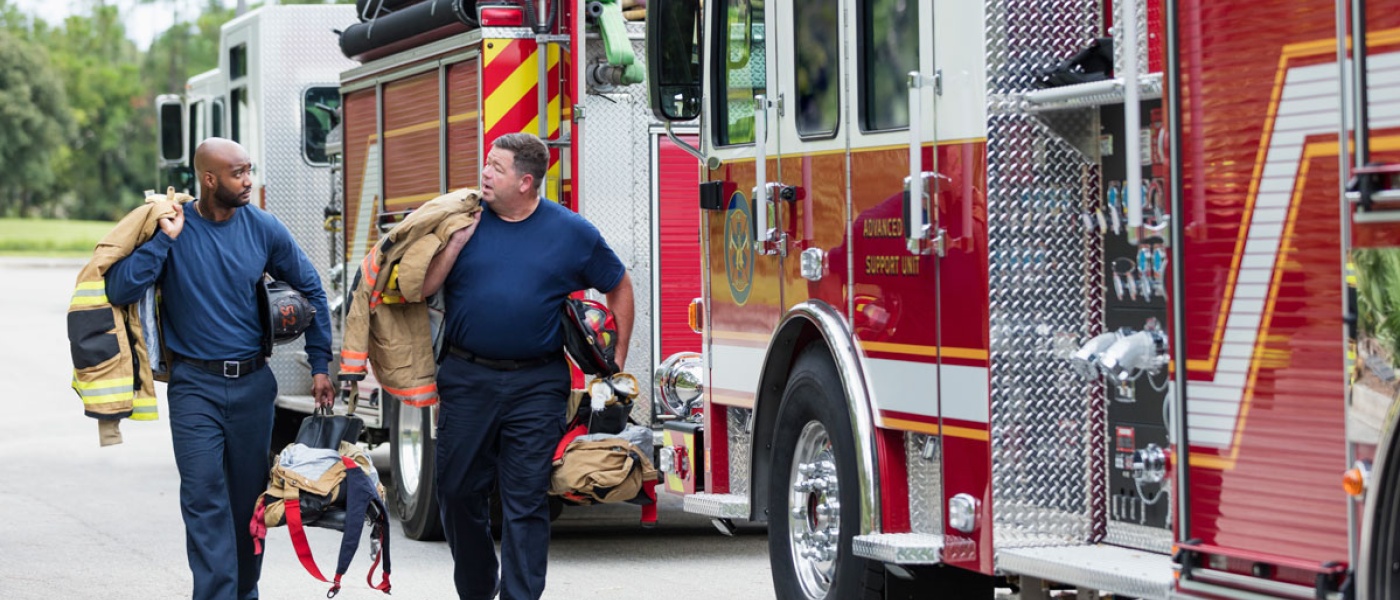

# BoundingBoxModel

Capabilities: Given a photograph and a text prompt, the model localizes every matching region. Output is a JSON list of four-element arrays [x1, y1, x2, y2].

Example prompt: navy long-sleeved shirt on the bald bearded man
[[106, 204, 330, 373]]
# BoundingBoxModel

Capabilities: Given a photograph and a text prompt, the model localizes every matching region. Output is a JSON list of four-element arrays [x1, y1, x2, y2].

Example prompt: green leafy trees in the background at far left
[[0, 0, 353, 220]]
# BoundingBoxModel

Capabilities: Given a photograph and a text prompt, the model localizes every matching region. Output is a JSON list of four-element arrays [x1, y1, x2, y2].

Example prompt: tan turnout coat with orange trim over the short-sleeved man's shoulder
[[340, 187, 482, 407]]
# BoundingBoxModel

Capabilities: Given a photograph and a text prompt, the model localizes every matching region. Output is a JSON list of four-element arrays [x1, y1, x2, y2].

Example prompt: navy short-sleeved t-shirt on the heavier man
[[442, 200, 626, 359]]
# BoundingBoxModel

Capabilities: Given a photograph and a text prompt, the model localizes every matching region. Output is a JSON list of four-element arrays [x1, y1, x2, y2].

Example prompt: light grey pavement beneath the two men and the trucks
[[0, 259, 774, 600]]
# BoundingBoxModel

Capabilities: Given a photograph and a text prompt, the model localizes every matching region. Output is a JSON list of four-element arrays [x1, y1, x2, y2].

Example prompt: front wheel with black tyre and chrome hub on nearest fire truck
[[769, 347, 883, 600]]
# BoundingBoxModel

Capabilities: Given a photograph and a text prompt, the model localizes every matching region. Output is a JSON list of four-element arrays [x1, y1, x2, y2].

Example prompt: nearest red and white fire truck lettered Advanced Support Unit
[[648, 0, 1400, 600]]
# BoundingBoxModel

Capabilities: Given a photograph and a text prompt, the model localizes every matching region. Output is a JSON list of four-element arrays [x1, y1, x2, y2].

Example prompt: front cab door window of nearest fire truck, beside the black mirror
[[711, 0, 769, 145]]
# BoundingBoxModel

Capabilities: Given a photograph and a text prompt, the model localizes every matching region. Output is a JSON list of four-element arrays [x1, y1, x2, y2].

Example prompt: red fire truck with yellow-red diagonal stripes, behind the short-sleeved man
[[326, 0, 700, 540]]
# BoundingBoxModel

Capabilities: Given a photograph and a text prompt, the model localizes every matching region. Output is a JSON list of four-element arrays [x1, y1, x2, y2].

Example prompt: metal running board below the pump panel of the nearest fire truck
[[997, 544, 1175, 600]]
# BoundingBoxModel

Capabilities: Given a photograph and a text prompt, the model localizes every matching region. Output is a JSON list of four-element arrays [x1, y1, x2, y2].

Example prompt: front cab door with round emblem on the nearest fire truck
[[701, 0, 784, 416]]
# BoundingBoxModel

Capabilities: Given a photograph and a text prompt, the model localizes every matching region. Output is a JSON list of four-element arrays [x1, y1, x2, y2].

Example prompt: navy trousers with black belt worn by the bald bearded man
[[167, 361, 277, 600]]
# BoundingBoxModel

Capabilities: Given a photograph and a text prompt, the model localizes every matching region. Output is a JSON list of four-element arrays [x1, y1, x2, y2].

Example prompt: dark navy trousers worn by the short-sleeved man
[[437, 354, 570, 600]]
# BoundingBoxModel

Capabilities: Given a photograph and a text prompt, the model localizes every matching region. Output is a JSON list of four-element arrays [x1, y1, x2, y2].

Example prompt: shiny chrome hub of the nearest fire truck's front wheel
[[788, 421, 841, 599]]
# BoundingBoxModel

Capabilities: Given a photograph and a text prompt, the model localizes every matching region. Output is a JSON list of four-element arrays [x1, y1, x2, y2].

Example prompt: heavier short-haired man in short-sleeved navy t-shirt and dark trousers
[[423, 133, 634, 600]]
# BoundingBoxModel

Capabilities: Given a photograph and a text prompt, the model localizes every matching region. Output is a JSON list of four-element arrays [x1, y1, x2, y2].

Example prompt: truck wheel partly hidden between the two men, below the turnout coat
[[384, 399, 442, 541]]
